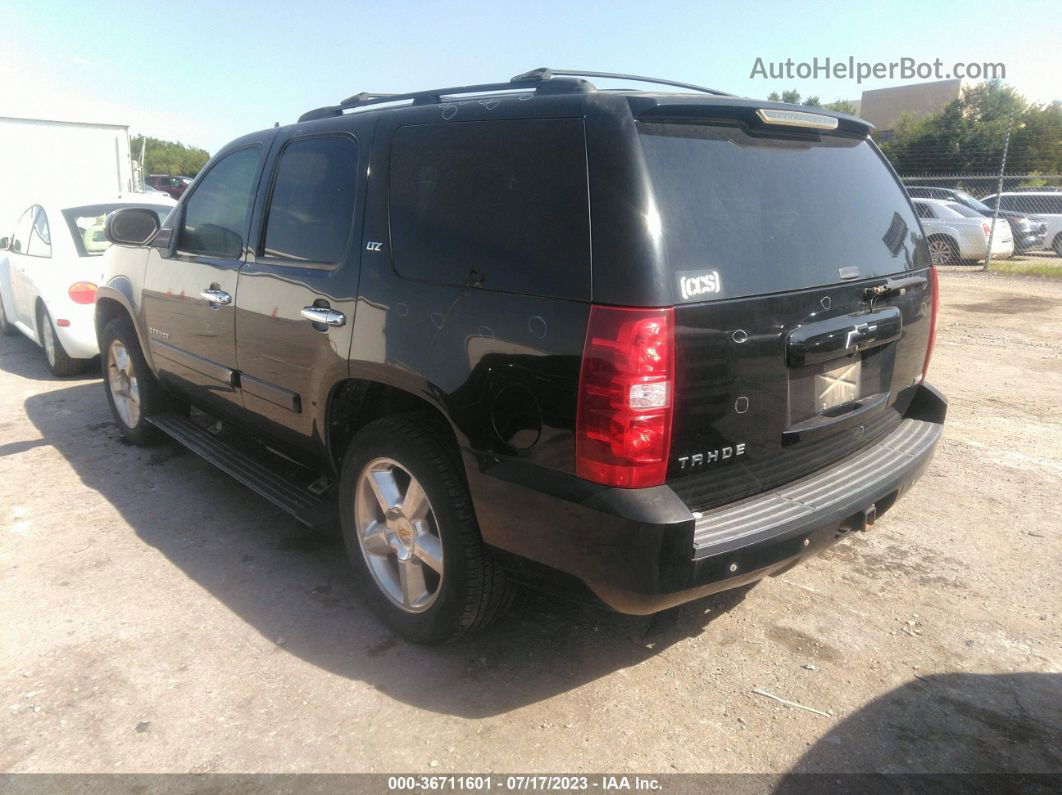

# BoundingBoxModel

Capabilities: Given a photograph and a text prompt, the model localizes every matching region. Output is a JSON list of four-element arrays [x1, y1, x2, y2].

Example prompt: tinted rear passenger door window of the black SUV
[[262, 136, 358, 264]]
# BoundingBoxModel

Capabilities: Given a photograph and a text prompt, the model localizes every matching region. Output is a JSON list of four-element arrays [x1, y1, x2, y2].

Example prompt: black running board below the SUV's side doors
[[148, 413, 339, 530]]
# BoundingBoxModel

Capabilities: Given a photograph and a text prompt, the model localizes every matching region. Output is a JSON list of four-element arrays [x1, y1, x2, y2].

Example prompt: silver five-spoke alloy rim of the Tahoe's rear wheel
[[354, 459, 443, 612]]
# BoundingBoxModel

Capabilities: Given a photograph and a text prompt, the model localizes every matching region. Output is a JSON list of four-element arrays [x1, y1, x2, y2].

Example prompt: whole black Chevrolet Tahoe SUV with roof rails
[[96, 69, 946, 642]]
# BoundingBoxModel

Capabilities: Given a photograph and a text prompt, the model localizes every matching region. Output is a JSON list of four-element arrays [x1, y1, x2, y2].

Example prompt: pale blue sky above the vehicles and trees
[[0, 0, 1062, 153]]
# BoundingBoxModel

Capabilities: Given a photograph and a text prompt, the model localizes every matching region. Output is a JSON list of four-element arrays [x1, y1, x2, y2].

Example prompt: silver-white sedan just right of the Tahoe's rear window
[[911, 198, 1014, 265]]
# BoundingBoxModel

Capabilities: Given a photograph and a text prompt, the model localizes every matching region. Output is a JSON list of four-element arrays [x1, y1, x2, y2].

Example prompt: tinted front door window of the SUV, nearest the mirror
[[177, 146, 261, 259]]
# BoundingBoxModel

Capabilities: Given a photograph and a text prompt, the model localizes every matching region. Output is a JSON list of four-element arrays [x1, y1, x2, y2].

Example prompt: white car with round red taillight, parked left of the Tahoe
[[0, 196, 176, 376]]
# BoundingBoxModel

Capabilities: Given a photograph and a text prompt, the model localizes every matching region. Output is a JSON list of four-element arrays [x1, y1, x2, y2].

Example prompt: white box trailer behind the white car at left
[[0, 116, 134, 234]]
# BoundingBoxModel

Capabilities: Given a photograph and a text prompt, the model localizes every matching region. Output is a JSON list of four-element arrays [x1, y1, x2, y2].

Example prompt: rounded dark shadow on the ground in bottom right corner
[[775, 673, 1062, 781]]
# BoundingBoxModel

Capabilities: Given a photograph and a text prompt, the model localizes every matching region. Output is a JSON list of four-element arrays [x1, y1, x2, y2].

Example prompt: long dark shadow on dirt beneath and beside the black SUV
[[22, 383, 748, 718]]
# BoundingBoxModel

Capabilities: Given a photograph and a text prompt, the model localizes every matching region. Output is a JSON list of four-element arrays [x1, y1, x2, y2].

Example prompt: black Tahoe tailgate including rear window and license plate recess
[[640, 114, 932, 511]]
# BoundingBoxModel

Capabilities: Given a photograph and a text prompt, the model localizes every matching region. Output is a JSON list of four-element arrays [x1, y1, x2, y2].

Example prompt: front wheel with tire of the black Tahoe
[[100, 317, 174, 447]]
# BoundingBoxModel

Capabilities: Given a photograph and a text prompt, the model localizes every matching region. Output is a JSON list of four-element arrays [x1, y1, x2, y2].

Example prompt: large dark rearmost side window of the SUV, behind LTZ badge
[[390, 119, 590, 299]]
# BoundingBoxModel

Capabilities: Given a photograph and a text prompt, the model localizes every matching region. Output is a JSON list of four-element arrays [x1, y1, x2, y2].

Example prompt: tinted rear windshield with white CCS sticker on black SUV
[[639, 124, 929, 301]]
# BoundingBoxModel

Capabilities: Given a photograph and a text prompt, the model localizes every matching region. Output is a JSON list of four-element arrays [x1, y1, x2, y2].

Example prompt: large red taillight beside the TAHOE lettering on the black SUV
[[576, 307, 674, 488]]
